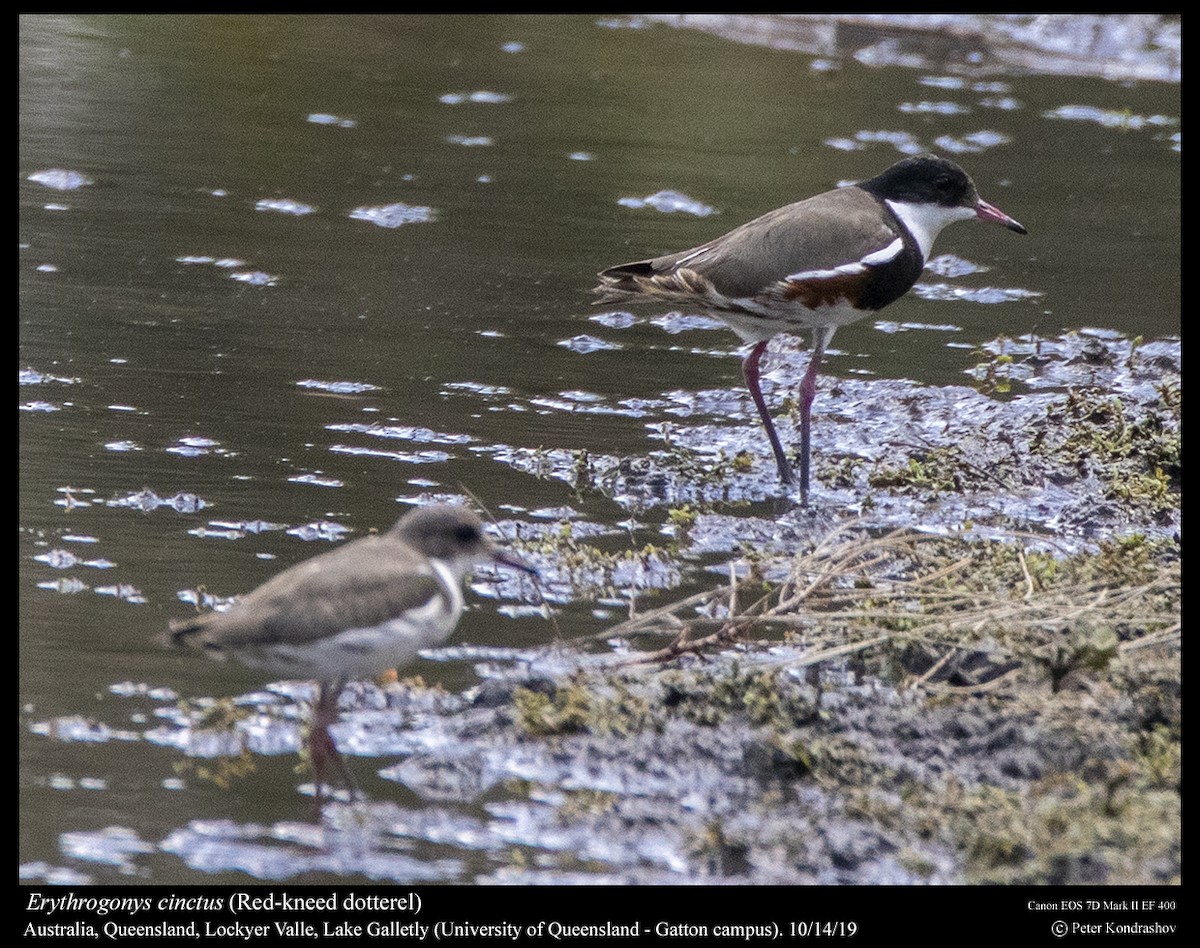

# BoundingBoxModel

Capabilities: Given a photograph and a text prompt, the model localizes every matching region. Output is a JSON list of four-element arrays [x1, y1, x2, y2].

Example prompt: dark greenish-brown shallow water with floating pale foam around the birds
[[18, 16, 1181, 882]]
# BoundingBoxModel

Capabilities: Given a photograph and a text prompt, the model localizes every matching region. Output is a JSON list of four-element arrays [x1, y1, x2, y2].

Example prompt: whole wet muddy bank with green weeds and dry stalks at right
[[34, 332, 1182, 884]]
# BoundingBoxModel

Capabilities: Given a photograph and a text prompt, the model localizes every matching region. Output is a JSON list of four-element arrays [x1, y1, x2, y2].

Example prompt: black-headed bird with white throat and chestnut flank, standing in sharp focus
[[594, 155, 1027, 504]]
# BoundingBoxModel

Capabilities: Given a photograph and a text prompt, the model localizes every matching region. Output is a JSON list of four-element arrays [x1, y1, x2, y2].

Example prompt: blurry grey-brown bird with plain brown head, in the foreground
[[169, 504, 534, 797]]
